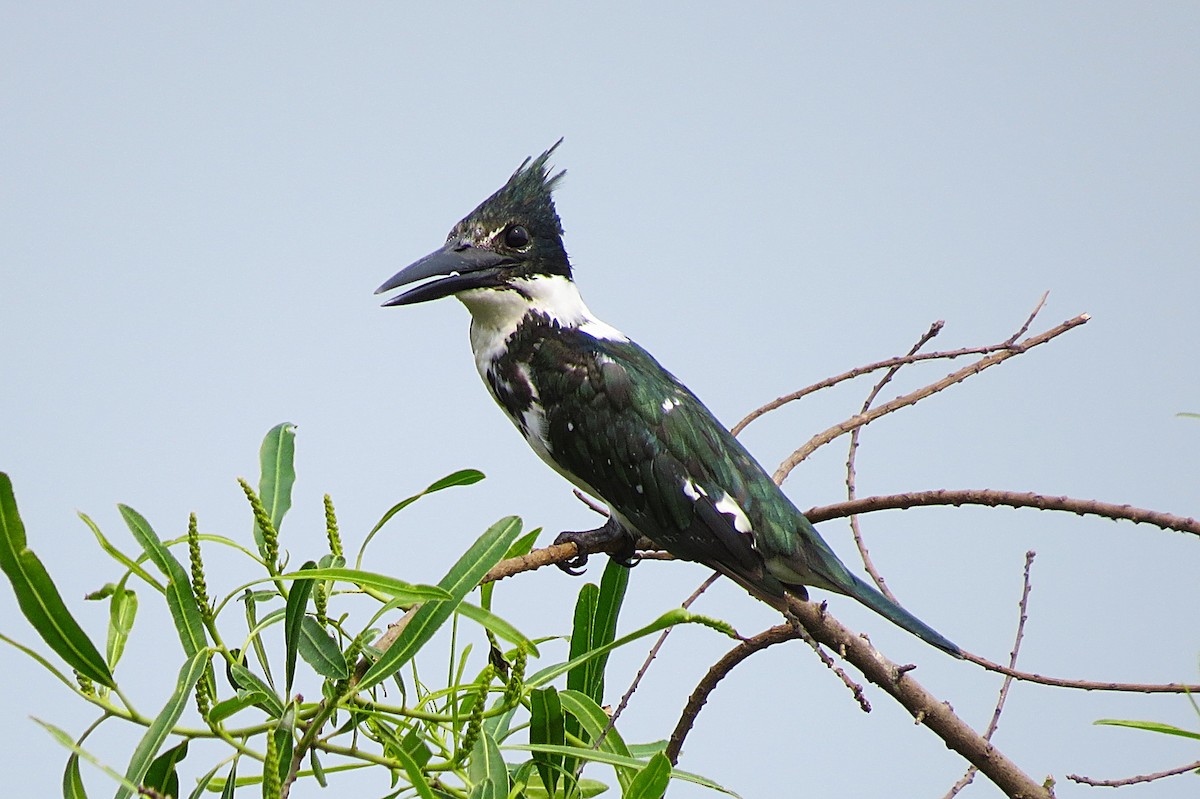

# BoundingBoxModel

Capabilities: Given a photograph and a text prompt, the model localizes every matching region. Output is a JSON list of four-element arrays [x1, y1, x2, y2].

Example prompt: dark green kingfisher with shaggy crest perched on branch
[[376, 139, 962, 657]]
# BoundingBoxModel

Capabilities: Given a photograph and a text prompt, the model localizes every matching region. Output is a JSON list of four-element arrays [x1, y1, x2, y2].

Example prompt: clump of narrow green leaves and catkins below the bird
[[0, 425, 728, 799]]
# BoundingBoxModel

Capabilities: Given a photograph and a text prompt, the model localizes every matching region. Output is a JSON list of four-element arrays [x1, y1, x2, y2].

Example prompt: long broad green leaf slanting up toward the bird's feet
[[358, 516, 521, 691]]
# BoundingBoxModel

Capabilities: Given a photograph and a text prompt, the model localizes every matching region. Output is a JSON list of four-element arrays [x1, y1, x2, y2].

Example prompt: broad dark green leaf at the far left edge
[[0, 471, 116, 687]]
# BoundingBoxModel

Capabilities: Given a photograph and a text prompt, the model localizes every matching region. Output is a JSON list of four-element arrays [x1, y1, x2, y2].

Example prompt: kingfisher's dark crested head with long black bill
[[376, 139, 571, 306]]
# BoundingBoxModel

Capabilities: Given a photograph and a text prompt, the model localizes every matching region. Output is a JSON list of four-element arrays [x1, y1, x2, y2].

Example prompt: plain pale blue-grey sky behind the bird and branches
[[0, 1, 1200, 798]]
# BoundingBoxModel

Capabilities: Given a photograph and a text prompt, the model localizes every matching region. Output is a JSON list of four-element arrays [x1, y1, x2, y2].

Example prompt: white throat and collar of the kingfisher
[[456, 275, 629, 379]]
